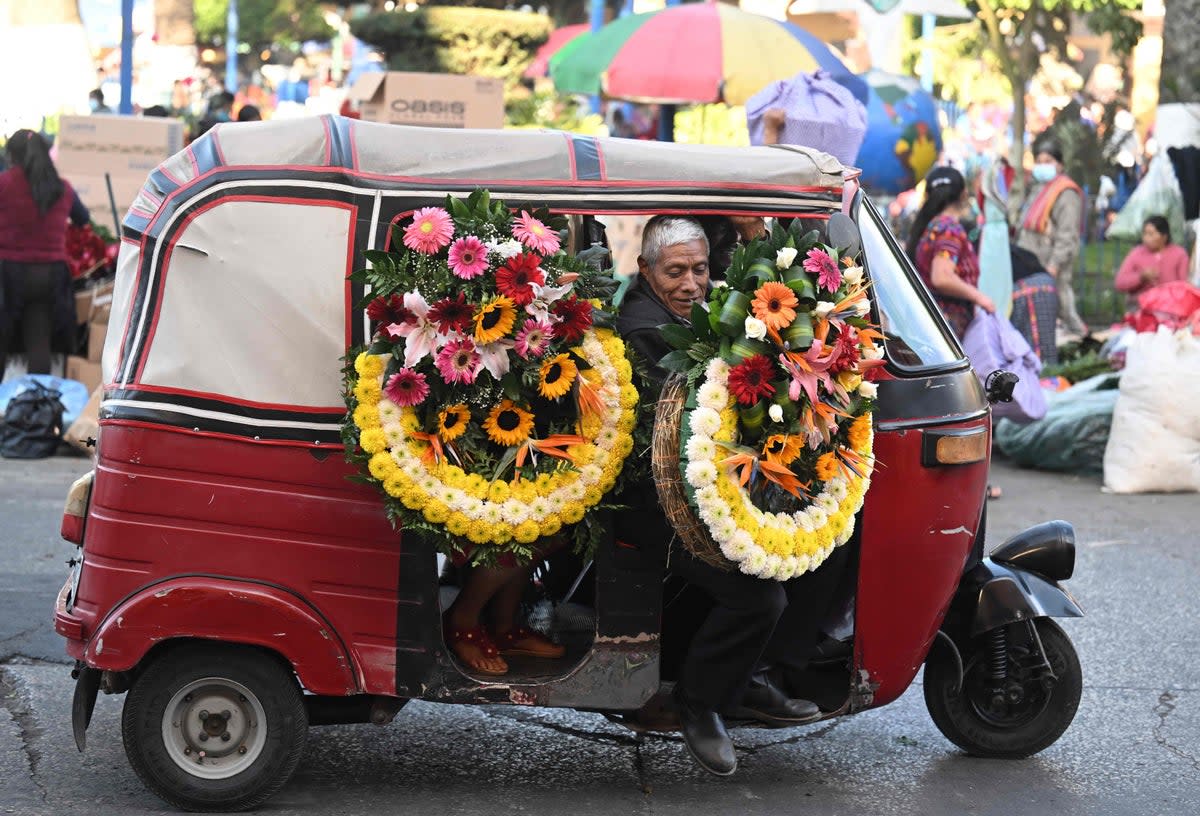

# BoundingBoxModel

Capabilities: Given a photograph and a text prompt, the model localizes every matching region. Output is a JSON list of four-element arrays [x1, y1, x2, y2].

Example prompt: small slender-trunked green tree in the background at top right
[[971, 0, 1141, 198]]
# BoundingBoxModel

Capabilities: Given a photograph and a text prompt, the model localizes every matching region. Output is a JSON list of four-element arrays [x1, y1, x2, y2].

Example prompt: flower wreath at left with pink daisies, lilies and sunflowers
[[343, 191, 638, 562]]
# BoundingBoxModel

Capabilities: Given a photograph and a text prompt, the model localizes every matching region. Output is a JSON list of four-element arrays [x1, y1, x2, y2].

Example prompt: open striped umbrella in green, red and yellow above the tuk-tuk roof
[[550, 1, 866, 104]]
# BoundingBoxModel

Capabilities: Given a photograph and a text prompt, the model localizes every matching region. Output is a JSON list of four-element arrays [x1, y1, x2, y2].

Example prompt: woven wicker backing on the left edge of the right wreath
[[650, 374, 733, 571]]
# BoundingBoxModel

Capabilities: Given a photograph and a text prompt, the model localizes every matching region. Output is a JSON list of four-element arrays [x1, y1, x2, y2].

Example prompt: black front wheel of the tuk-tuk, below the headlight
[[925, 618, 1084, 760]]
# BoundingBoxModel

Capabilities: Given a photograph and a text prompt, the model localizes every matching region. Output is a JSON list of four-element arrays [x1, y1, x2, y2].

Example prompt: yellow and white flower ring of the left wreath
[[353, 329, 637, 545]]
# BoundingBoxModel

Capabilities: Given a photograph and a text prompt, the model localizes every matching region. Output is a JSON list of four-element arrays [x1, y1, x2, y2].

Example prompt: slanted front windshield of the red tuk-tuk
[[852, 192, 970, 377]]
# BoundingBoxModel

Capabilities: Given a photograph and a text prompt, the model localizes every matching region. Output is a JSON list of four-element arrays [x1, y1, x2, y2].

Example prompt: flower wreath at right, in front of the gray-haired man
[[661, 221, 883, 581]]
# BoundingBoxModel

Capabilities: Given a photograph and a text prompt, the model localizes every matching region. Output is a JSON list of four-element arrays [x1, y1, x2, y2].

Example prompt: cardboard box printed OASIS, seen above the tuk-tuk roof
[[348, 71, 504, 128]]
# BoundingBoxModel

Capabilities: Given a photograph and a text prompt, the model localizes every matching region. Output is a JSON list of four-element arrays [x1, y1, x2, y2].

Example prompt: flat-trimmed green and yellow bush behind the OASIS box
[[350, 6, 553, 90]]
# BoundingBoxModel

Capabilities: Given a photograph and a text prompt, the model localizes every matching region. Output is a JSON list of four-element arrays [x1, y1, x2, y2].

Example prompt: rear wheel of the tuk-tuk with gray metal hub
[[121, 644, 308, 811]]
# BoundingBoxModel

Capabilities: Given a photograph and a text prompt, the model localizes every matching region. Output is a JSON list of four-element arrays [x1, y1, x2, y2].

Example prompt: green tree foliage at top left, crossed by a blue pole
[[196, 0, 335, 49]]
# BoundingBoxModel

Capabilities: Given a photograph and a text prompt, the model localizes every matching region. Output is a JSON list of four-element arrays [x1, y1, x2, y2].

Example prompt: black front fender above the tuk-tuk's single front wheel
[[960, 558, 1084, 637]]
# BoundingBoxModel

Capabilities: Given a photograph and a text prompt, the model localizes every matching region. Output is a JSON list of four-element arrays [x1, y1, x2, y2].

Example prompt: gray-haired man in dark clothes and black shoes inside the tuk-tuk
[[616, 216, 820, 776]]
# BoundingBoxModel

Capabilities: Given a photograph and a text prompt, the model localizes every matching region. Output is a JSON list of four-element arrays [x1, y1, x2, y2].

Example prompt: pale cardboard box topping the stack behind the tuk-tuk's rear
[[54, 115, 184, 177]]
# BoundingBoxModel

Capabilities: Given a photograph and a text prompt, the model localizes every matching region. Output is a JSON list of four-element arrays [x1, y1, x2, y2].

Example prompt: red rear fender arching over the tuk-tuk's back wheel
[[83, 576, 359, 696]]
